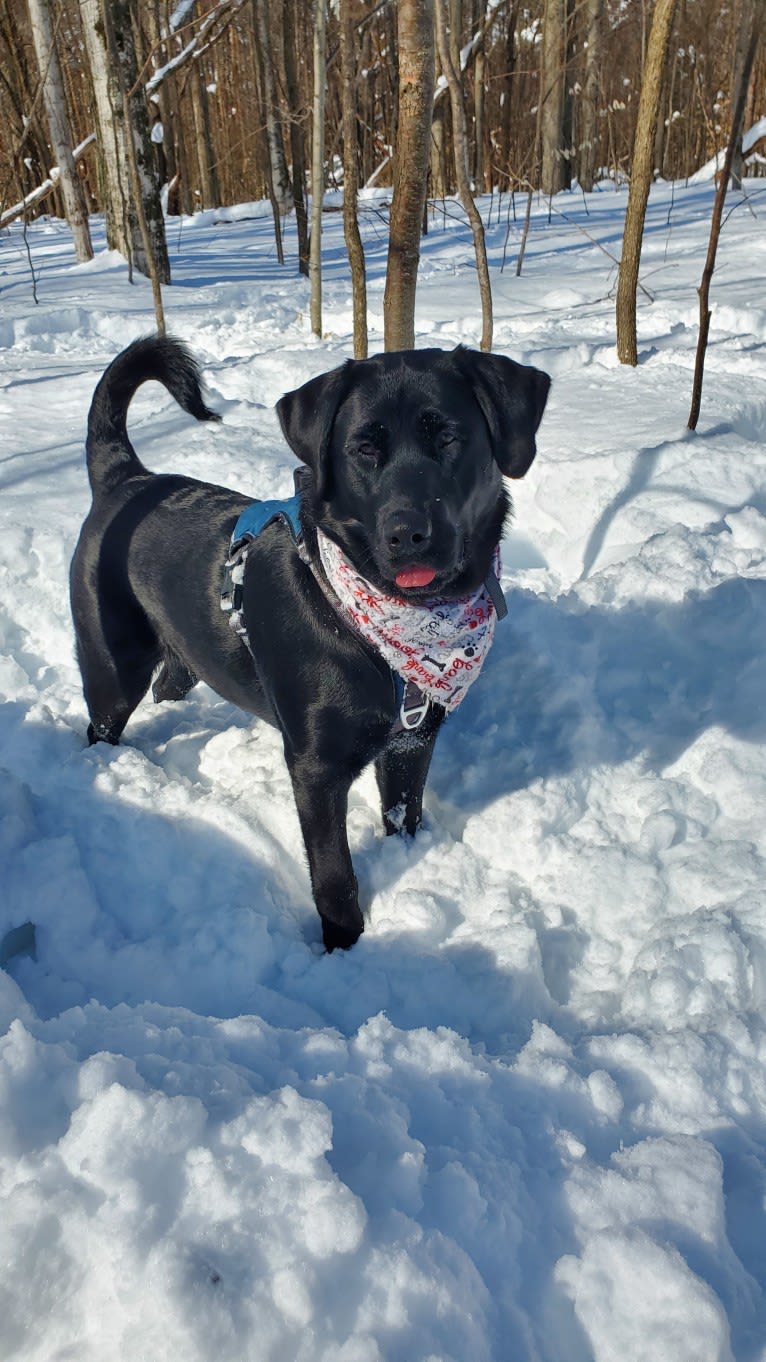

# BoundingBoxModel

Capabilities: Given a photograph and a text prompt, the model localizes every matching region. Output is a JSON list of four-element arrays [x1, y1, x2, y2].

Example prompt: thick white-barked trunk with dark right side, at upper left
[[80, 0, 170, 283]]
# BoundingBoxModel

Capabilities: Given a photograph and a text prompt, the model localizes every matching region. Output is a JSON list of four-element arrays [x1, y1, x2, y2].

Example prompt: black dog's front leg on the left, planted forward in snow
[[288, 757, 364, 951]]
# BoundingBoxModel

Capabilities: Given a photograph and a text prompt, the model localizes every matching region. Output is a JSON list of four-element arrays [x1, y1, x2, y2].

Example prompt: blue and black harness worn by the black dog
[[221, 493, 431, 731]]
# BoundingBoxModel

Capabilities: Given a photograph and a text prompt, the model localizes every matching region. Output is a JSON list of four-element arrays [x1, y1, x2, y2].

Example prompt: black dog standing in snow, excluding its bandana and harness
[[71, 338, 549, 949]]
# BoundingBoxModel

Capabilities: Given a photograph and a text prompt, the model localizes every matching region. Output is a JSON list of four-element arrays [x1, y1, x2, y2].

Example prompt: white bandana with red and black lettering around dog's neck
[[316, 530, 500, 711]]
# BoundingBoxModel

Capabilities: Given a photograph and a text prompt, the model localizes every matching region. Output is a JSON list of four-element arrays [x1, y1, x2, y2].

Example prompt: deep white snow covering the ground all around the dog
[[0, 181, 766, 1362]]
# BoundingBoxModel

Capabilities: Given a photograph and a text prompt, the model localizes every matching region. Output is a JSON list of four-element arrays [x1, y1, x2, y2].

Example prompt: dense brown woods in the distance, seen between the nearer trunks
[[0, 0, 766, 242]]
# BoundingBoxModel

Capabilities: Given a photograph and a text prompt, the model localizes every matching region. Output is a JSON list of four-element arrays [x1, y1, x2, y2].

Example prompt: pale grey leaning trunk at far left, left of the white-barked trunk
[[27, 0, 93, 262]]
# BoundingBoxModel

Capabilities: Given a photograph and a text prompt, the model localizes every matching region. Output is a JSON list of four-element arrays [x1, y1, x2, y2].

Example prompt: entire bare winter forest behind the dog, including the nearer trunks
[[0, 0, 766, 397]]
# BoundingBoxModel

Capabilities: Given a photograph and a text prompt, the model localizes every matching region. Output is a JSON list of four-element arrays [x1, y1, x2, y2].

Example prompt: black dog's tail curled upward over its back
[[86, 335, 221, 493]]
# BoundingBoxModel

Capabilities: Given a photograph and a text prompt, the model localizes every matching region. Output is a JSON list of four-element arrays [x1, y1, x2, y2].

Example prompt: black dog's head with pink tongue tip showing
[[277, 347, 551, 599]]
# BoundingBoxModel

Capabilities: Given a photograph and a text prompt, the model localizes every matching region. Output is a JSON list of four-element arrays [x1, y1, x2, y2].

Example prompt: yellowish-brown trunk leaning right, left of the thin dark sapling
[[616, 0, 676, 365]]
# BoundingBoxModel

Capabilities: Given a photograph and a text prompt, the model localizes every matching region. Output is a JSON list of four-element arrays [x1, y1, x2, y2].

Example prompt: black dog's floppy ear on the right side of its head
[[454, 346, 551, 478]]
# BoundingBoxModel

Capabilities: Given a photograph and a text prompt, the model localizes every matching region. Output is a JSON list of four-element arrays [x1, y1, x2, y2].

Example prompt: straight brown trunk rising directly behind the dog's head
[[383, 0, 435, 350]]
